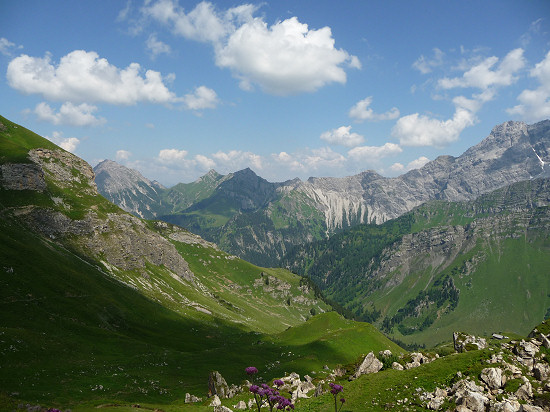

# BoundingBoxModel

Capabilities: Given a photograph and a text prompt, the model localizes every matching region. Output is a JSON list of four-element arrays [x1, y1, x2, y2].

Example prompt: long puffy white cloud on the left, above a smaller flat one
[[7, 50, 178, 105]]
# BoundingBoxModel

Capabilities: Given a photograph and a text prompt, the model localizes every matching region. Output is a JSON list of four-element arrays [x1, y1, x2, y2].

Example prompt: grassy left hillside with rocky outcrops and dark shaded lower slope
[[0, 116, 401, 410]]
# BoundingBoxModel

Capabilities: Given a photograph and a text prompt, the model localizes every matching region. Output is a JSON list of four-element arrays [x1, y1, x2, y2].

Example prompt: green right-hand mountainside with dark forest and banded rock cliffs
[[283, 178, 550, 346]]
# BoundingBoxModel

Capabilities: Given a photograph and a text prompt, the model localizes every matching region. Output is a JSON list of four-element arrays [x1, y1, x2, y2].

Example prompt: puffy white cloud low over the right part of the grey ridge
[[392, 107, 477, 148]]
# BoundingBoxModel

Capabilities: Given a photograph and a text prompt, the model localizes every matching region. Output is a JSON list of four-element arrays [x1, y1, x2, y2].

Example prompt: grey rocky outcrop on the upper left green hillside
[[0, 148, 193, 280]]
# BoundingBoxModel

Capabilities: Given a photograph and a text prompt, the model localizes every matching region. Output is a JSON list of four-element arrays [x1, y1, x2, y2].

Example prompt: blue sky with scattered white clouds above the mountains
[[0, 0, 550, 183]]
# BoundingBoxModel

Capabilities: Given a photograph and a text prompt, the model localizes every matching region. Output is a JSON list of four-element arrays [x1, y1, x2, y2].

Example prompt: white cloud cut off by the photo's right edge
[[507, 52, 550, 121]]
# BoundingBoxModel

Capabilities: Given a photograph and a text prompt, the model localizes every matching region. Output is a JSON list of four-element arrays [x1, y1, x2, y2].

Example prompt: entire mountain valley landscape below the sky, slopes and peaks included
[[0, 116, 550, 411]]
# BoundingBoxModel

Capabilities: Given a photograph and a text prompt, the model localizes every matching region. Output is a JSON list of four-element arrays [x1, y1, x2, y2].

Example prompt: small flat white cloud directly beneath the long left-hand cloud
[[34, 102, 105, 126]]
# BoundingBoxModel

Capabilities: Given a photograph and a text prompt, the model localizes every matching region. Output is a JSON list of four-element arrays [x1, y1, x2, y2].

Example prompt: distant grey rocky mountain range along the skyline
[[94, 120, 550, 266]]
